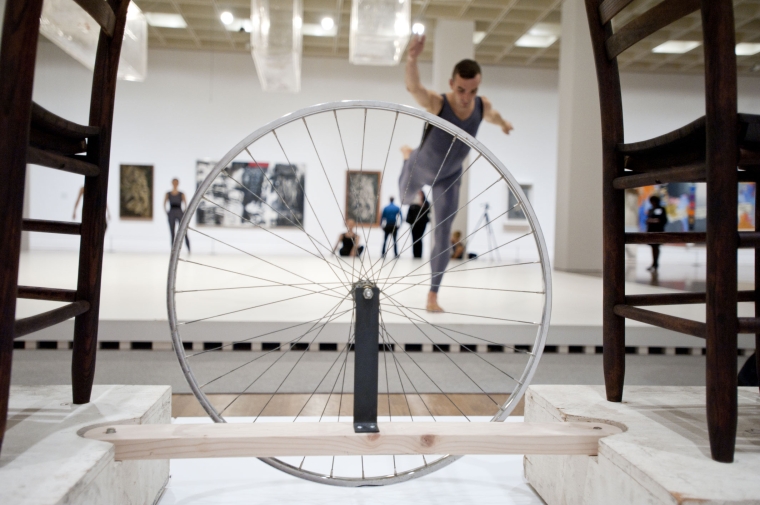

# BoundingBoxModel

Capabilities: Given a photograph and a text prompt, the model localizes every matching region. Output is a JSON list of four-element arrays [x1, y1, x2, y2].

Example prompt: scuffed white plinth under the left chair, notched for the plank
[[0, 386, 171, 505]]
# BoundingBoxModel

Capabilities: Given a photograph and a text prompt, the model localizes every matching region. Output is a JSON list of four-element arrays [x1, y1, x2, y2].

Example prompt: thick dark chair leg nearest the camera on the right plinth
[[702, 0, 738, 463]]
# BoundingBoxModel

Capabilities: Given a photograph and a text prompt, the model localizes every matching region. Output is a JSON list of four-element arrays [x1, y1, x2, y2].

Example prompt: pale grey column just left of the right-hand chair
[[554, 0, 602, 272]]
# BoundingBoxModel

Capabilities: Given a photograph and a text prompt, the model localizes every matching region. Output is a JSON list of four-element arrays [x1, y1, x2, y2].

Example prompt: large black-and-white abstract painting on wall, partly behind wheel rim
[[196, 161, 306, 227]]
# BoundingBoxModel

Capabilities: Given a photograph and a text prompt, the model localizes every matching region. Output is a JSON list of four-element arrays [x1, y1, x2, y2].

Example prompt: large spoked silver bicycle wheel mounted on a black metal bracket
[[167, 101, 551, 486]]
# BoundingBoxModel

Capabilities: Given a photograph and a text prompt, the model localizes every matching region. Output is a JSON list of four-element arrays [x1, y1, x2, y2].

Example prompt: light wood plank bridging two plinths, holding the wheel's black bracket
[[84, 422, 622, 461]]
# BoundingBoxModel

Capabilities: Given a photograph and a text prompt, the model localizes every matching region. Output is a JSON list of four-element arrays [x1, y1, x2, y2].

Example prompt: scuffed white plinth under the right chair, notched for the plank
[[524, 386, 760, 505]]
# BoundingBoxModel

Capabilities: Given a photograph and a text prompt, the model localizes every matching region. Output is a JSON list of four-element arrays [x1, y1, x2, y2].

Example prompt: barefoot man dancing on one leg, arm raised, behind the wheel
[[399, 35, 513, 312]]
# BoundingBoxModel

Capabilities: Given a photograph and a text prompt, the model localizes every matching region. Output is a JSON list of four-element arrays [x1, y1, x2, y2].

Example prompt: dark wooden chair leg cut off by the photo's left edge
[[0, 0, 42, 448]]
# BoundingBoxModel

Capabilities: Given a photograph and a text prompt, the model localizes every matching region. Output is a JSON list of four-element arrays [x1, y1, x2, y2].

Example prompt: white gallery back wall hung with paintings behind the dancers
[[29, 42, 760, 255]]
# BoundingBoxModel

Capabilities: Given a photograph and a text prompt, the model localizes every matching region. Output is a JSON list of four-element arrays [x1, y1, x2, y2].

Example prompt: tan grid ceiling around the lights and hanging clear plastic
[[135, 0, 760, 75]]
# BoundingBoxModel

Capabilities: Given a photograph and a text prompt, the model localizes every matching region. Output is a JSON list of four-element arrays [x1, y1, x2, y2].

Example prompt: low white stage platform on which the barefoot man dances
[[11, 248, 755, 352]]
